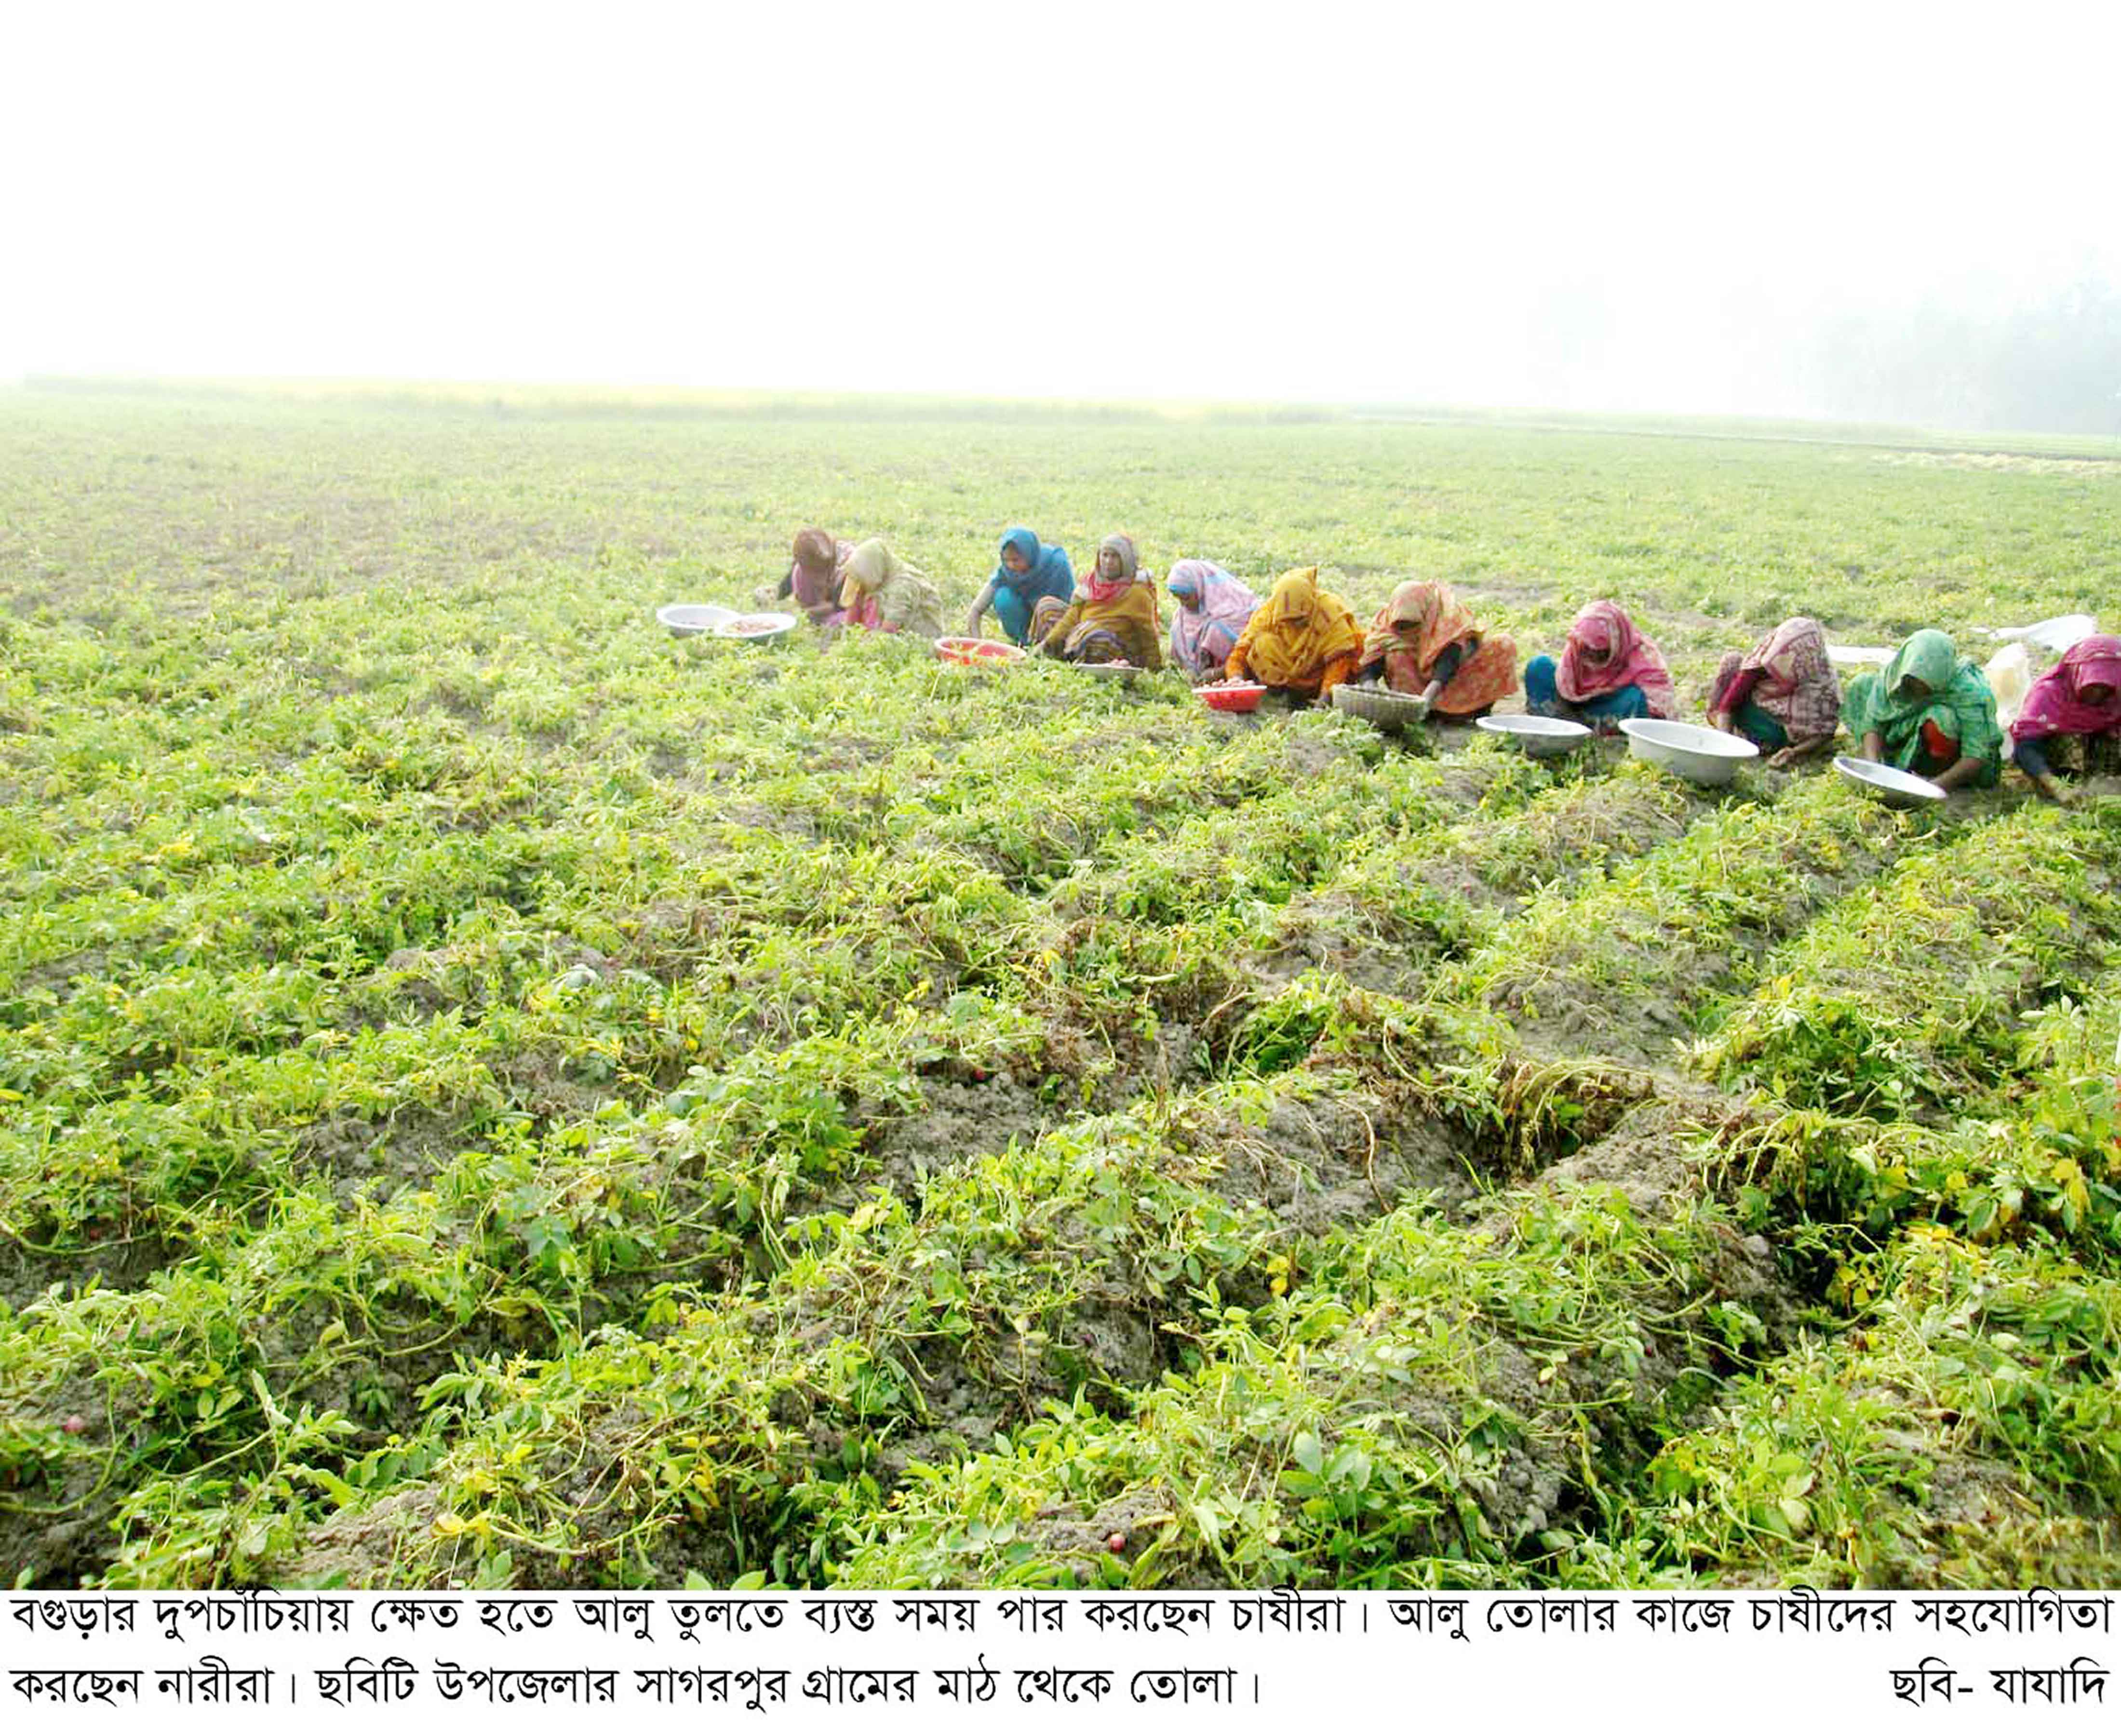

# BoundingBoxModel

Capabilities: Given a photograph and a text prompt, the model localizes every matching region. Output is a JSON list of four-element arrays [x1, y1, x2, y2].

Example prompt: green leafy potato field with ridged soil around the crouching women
[[0, 392, 2121, 1588]]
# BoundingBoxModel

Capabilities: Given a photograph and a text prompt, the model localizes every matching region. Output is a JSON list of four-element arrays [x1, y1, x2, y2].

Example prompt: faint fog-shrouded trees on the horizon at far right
[[1809, 278, 2121, 437]]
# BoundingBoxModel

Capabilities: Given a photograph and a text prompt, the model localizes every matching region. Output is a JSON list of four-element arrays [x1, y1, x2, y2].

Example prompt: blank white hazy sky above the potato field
[[0, 0, 2121, 409]]
